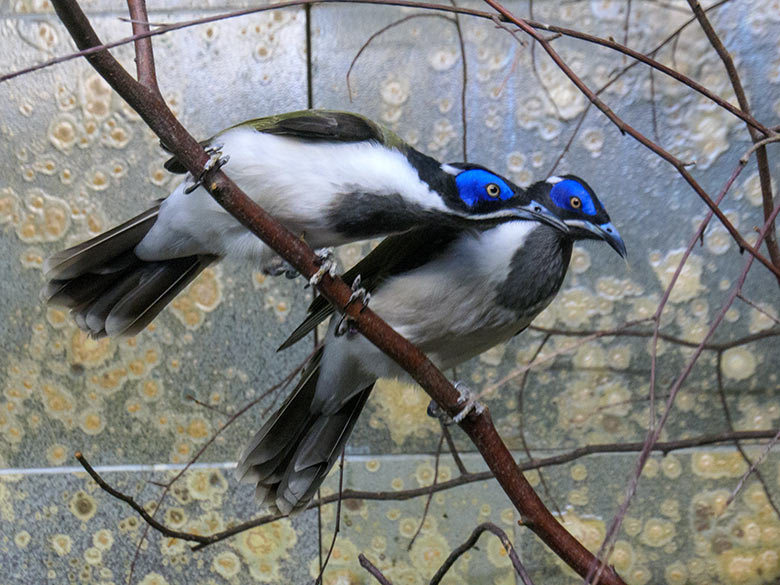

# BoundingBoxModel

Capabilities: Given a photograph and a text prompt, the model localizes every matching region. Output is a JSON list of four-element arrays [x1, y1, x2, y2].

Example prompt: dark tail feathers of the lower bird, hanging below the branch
[[236, 352, 373, 514]]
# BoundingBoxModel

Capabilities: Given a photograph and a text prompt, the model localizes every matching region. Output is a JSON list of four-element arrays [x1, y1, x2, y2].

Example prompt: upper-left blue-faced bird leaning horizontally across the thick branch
[[42, 110, 566, 337]]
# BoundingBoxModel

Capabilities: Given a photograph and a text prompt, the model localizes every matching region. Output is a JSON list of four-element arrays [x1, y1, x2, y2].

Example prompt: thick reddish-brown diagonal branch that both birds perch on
[[48, 0, 623, 585]]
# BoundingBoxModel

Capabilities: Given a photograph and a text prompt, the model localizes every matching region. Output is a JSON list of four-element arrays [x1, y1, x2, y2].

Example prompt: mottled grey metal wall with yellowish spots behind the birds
[[0, 0, 780, 585]]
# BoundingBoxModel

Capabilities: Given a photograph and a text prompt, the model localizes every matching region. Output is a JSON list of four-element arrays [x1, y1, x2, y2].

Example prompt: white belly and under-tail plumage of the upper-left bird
[[135, 127, 446, 263]]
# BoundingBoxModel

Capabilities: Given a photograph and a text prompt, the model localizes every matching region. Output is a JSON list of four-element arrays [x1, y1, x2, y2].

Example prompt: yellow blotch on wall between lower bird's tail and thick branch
[[369, 380, 438, 445]]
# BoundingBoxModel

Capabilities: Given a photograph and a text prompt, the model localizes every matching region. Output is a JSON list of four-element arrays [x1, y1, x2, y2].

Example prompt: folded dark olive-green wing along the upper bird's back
[[162, 110, 406, 173]]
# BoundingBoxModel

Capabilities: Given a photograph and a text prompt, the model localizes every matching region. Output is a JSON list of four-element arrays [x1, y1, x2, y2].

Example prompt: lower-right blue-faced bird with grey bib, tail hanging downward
[[236, 176, 626, 514]]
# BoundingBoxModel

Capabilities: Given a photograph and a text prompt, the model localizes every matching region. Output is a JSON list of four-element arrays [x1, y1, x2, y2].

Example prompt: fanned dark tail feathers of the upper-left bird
[[41, 205, 215, 337]]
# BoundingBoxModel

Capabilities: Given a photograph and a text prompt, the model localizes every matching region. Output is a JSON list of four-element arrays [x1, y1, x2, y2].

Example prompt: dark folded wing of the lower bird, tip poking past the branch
[[277, 228, 460, 351]]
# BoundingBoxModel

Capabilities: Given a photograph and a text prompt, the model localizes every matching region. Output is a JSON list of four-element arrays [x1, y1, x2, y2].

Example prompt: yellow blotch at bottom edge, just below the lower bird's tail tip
[[232, 518, 298, 583]]
